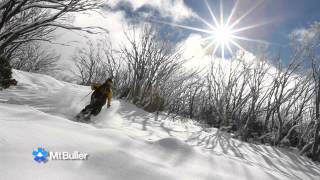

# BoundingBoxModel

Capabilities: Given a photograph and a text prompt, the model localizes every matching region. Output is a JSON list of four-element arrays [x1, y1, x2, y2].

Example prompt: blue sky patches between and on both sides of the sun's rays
[[105, 0, 320, 57]]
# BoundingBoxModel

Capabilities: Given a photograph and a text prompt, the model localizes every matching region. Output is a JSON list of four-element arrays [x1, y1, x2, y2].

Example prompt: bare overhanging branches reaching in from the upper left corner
[[0, 0, 99, 57]]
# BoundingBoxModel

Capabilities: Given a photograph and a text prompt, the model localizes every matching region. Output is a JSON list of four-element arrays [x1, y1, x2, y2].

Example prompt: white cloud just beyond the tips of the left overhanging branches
[[48, 8, 139, 78]]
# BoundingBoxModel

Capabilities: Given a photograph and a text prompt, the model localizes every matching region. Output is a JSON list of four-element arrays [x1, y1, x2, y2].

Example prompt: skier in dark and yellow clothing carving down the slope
[[76, 78, 113, 120]]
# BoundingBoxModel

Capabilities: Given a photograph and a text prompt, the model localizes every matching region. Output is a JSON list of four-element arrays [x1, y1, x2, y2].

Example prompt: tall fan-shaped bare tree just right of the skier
[[121, 24, 183, 105]]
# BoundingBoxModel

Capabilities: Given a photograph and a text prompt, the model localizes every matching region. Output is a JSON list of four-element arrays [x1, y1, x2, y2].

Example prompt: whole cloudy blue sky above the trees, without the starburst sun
[[52, 0, 320, 76]]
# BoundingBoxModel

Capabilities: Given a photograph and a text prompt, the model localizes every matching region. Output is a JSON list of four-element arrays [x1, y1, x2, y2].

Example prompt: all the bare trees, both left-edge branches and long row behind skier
[[0, 0, 320, 160]]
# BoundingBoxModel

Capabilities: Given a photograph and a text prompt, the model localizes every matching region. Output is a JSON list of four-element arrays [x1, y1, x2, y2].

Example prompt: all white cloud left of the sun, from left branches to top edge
[[50, 0, 195, 78]]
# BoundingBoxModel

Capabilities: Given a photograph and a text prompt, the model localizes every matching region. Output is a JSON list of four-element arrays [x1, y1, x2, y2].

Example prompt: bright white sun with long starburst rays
[[155, 0, 270, 59]]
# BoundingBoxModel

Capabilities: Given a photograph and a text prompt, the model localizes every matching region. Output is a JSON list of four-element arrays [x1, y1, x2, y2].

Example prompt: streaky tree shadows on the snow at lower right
[[186, 129, 320, 180]]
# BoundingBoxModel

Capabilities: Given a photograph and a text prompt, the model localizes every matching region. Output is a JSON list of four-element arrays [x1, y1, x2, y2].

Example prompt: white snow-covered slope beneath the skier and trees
[[0, 70, 320, 180]]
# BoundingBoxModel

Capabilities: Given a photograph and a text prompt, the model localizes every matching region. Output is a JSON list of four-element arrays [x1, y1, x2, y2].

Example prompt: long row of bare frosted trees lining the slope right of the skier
[[75, 22, 320, 160]]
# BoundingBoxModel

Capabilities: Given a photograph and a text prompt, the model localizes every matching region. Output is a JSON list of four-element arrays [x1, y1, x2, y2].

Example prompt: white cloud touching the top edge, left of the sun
[[108, 0, 196, 21]]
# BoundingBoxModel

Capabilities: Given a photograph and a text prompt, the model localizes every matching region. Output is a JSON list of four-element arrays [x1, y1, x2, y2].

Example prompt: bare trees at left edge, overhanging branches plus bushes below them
[[0, 0, 101, 86]]
